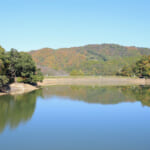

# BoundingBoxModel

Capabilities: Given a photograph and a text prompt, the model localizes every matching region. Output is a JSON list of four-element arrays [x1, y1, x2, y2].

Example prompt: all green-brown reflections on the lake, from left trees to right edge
[[0, 86, 150, 132]]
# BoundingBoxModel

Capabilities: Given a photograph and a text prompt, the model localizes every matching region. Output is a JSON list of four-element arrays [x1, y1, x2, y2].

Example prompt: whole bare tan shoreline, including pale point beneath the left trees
[[0, 76, 150, 96]]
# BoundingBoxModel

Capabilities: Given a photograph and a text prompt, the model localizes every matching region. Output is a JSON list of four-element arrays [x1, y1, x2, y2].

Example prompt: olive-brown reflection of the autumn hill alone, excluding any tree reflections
[[43, 86, 135, 104]]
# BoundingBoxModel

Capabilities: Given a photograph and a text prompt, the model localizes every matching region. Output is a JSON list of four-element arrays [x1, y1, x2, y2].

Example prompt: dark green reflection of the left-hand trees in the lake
[[0, 90, 42, 132]]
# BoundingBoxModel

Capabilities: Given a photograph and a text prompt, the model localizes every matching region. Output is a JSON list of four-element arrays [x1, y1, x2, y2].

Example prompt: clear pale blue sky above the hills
[[0, 0, 150, 51]]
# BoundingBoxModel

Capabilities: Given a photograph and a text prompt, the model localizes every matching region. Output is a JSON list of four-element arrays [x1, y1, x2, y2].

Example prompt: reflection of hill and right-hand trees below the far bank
[[43, 86, 150, 106]]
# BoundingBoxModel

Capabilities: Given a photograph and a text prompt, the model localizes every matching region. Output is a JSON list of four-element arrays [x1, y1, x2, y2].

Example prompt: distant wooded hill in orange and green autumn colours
[[30, 44, 150, 75]]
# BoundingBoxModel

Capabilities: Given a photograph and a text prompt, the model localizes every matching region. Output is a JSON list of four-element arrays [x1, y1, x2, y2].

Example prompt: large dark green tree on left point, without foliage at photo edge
[[5, 49, 43, 84]]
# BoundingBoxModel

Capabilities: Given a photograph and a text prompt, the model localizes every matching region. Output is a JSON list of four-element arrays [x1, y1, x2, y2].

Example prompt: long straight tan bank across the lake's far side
[[38, 76, 150, 86]]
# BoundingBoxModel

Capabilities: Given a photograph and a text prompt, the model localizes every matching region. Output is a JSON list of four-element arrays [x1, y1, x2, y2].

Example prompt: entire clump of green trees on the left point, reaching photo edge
[[0, 46, 43, 92]]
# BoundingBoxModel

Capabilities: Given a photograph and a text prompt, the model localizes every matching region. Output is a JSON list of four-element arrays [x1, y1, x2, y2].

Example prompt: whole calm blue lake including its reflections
[[0, 86, 150, 150]]
